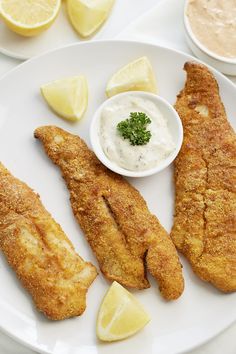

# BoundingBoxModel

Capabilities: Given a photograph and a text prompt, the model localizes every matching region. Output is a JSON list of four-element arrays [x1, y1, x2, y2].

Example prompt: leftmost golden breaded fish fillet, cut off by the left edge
[[0, 163, 97, 320]]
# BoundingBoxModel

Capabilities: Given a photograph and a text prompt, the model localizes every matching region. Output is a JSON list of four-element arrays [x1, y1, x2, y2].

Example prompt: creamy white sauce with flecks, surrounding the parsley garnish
[[99, 94, 175, 171]]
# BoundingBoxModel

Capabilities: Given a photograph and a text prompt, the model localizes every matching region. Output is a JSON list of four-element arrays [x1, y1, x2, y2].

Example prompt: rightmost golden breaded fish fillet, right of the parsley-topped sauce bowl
[[171, 62, 236, 292]]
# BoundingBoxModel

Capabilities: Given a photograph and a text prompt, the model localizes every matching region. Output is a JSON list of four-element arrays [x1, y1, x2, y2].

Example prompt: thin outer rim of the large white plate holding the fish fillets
[[0, 38, 236, 354]]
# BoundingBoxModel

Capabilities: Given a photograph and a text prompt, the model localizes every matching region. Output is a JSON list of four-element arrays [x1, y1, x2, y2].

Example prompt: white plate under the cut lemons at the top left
[[0, 0, 159, 59]]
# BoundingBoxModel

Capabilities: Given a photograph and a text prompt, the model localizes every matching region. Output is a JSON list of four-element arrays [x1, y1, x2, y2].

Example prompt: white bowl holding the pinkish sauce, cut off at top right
[[184, 0, 236, 75]]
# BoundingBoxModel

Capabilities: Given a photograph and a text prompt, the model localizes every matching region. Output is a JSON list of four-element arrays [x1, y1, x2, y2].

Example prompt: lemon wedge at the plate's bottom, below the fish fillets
[[97, 281, 150, 342]]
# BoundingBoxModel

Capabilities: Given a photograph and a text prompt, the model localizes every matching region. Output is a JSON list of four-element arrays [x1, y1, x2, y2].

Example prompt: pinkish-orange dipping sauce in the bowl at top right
[[187, 0, 236, 58]]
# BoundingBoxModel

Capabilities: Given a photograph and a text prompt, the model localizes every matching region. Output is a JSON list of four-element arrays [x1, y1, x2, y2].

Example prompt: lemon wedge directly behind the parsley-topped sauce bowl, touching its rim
[[106, 57, 157, 97]]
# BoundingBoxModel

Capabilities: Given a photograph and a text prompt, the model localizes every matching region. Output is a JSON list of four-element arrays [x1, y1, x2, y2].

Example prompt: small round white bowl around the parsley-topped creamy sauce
[[90, 91, 183, 177]]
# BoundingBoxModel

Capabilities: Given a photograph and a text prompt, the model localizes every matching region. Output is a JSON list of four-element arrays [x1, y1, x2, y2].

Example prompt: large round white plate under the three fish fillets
[[0, 41, 236, 354]]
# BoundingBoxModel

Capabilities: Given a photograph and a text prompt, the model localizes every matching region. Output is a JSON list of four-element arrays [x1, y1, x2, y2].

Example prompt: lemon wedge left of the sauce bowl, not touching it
[[41, 75, 88, 121]]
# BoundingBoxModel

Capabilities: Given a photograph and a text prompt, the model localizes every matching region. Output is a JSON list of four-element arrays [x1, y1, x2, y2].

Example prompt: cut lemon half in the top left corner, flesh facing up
[[0, 0, 61, 37]]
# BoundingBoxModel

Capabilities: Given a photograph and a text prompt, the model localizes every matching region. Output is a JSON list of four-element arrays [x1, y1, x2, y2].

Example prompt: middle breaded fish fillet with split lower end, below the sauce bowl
[[35, 126, 184, 299]]
